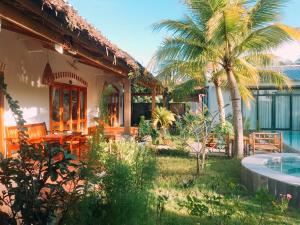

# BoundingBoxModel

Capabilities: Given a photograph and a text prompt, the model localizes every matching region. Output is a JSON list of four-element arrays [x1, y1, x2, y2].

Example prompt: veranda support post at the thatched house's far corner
[[124, 79, 131, 135]]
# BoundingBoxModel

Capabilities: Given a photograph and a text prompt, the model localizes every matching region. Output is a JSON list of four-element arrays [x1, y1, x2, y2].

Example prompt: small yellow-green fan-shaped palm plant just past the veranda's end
[[153, 107, 175, 135]]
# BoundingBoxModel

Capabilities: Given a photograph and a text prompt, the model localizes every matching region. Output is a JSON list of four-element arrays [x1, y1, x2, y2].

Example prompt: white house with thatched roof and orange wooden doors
[[0, 0, 157, 157]]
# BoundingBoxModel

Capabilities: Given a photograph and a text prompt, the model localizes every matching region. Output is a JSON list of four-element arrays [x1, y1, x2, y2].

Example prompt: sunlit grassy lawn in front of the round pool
[[155, 155, 300, 225]]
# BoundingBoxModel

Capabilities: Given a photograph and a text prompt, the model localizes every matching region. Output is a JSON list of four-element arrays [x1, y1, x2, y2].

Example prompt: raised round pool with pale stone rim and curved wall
[[241, 153, 300, 208]]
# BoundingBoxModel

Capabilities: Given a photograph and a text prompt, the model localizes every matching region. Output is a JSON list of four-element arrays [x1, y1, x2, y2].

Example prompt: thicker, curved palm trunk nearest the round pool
[[226, 68, 244, 158]]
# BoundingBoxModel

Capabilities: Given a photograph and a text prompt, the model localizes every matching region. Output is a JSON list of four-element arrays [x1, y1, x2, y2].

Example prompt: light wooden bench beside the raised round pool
[[249, 132, 283, 154]]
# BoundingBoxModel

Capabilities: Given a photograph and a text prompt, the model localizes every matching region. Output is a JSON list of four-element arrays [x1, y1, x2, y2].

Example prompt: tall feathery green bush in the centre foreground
[[65, 141, 156, 225]]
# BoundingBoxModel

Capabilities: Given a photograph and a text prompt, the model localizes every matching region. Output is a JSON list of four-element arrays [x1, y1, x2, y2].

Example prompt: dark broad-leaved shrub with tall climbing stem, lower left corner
[[0, 76, 84, 225]]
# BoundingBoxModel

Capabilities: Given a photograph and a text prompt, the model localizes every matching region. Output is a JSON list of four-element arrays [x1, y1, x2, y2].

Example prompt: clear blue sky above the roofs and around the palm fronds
[[68, 0, 300, 66]]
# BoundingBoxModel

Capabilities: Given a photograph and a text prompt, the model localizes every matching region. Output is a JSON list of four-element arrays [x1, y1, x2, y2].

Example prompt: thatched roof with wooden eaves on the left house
[[0, 0, 160, 88]]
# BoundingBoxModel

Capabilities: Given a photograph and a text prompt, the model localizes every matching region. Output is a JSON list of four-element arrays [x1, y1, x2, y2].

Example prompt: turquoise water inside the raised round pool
[[266, 157, 300, 177]]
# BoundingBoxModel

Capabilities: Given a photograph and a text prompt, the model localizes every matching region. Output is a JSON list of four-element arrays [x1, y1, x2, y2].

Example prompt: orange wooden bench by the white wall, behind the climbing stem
[[5, 122, 48, 157]]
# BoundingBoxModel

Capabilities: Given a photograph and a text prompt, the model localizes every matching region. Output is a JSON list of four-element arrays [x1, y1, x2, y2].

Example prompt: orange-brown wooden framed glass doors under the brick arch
[[50, 83, 87, 132]]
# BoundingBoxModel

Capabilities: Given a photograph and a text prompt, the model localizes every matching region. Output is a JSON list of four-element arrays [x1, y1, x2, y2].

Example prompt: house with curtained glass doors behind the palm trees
[[208, 65, 300, 131]]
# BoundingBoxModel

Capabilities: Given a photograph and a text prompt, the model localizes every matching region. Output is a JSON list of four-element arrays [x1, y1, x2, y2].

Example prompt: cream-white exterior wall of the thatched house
[[0, 29, 123, 132]]
